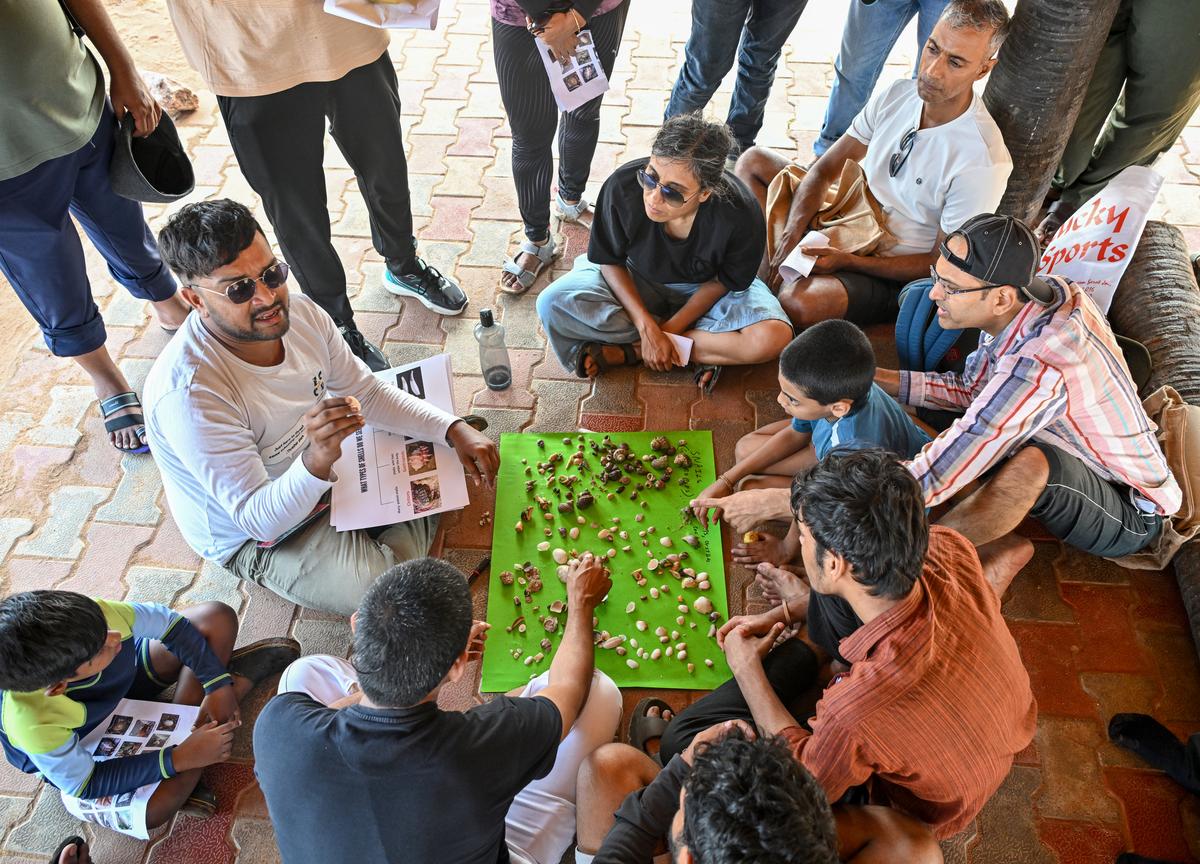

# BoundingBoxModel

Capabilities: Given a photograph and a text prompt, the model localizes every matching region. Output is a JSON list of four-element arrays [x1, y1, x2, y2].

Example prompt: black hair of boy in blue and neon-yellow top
[[0, 590, 108, 692]]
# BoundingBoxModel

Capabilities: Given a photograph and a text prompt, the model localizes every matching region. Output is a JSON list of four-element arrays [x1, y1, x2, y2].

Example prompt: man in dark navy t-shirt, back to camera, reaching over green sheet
[[254, 554, 622, 864]]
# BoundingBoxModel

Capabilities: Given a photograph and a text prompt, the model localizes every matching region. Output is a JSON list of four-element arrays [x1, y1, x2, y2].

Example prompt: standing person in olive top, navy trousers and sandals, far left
[[0, 0, 188, 452]]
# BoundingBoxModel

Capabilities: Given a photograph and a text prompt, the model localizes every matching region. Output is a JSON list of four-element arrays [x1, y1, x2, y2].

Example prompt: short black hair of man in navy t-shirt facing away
[[353, 558, 472, 708]]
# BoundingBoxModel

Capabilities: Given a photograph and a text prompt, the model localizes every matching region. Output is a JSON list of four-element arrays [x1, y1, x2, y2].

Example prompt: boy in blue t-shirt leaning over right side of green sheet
[[692, 320, 930, 566]]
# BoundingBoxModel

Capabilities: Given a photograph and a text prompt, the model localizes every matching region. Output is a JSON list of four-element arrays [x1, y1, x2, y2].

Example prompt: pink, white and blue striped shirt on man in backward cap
[[900, 277, 1182, 515]]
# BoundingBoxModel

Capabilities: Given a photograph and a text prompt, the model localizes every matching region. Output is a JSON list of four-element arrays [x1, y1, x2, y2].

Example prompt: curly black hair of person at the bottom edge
[[682, 730, 838, 864]]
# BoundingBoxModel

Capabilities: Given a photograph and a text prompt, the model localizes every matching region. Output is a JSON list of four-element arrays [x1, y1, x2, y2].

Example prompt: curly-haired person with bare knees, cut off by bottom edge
[[575, 720, 942, 864]]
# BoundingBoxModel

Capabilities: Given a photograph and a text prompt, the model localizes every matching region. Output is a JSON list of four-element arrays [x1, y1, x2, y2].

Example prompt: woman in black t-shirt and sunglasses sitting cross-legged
[[538, 114, 792, 392]]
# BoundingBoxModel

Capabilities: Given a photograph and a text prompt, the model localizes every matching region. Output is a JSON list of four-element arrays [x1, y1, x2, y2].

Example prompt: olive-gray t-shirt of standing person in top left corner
[[0, 0, 104, 180]]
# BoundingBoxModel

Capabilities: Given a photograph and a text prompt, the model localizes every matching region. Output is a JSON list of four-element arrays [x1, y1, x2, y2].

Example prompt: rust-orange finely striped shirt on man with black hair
[[781, 526, 1037, 838]]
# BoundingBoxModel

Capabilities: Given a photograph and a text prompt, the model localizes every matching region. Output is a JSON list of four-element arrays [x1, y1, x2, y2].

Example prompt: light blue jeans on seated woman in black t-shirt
[[538, 256, 791, 371]]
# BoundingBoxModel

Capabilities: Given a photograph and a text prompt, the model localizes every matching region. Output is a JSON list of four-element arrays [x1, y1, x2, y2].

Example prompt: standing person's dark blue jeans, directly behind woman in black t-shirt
[[664, 0, 811, 156]]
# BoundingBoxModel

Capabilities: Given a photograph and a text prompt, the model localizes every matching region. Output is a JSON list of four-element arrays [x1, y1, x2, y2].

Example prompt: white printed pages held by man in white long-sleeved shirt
[[331, 354, 468, 530]]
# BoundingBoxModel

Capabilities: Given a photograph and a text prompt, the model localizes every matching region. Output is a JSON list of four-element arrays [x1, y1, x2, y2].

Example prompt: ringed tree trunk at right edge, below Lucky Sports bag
[[1109, 222, 1200, 652]]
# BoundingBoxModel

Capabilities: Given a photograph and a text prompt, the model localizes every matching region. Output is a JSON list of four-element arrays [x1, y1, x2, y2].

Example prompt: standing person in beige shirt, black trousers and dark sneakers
[[167, 0, 467, 371]]
